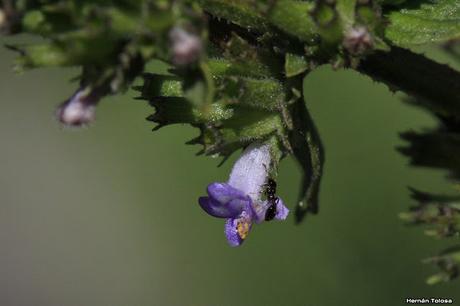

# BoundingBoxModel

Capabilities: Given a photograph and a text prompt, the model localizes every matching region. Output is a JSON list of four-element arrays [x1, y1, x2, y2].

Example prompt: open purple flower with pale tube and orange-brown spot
[[198, 144, 289, 246]]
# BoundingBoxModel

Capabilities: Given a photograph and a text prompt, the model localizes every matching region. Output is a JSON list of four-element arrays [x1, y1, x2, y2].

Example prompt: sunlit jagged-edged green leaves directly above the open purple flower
[[142, 56, 287, 160]]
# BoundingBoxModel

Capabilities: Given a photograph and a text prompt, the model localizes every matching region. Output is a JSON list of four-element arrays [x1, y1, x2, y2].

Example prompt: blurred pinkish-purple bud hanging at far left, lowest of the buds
[[56, 89, 99, 126]]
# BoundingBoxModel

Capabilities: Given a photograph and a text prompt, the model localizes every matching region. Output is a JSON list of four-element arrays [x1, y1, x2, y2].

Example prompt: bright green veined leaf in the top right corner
[[385, 0, 460, 47]]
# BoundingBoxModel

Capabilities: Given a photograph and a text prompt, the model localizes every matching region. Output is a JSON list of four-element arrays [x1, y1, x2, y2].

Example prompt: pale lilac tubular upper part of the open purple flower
[[228, 143, 271, 201]]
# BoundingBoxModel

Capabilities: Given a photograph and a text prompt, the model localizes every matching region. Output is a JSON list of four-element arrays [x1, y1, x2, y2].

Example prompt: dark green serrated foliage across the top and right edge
[[0, 0, 460, 283]]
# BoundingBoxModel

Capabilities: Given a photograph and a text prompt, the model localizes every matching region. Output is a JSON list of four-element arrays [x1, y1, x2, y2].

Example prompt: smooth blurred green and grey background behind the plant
[[0, 35, 460, 306]]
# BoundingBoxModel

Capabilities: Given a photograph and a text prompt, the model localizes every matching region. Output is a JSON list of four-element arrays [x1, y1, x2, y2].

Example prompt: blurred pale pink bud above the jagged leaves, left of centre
[[169, 27, 203, 66]]
